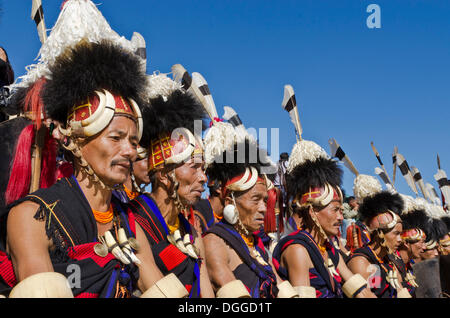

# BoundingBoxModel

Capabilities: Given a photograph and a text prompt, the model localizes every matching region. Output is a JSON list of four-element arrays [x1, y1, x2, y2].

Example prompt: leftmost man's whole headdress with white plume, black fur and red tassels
[[7, 0, 147, 201]]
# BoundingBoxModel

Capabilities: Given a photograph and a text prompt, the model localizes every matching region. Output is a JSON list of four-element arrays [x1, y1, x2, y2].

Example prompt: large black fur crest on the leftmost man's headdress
[[42, 41, 147, 123]]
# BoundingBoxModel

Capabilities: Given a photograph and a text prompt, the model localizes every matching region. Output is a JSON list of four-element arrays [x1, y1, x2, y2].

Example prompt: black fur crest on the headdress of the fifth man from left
[[358, 191, 404, 221]]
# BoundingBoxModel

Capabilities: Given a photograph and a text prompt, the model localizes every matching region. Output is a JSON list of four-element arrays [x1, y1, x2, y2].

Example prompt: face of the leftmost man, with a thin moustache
[[81, 116, 138, 186]]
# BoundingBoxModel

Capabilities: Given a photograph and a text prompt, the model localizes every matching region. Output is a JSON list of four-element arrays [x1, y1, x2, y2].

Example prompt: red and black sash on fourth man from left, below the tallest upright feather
[[272, 229, 343, 298]]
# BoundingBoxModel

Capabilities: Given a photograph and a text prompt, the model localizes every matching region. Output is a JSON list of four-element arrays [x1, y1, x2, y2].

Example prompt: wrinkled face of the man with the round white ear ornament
[[235, 183, 268, 232]]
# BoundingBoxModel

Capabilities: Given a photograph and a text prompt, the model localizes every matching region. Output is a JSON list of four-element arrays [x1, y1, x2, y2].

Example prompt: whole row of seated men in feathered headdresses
[[0, 0, 450, 298]]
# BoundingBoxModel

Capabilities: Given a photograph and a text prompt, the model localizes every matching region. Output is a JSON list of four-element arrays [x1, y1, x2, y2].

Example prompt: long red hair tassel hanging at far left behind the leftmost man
[[5, 125, 36, 204]]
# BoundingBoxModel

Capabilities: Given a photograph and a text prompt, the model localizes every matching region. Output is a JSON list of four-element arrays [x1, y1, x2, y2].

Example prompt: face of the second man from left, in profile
[[175, 158, 208, 205]]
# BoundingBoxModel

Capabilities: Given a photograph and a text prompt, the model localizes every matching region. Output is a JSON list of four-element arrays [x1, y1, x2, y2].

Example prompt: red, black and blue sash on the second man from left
[[129, 194, 201, 298]]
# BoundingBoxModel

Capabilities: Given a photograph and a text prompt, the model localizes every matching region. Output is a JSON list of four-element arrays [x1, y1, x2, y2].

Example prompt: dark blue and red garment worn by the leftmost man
[[0, 176, 139, 298]]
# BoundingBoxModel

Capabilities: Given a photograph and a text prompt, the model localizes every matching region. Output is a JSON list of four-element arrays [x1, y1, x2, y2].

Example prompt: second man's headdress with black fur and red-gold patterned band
[[141, 74, 206, 172]]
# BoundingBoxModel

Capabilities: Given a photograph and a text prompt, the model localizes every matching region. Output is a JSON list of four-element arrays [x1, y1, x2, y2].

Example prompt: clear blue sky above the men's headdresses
[[0, 0, 450, 199]]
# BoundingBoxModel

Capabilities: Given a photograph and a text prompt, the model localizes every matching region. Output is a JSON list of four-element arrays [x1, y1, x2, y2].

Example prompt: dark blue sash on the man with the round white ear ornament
[[207, 221, 278, 298]]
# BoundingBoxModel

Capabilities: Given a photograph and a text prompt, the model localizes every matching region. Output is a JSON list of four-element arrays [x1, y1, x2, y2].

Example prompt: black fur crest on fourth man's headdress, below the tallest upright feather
[[286, 158, 343, 198]]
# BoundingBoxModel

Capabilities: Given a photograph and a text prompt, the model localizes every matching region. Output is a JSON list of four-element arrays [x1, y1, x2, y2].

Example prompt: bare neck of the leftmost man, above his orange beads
[[76, 172, 112, 212]]
